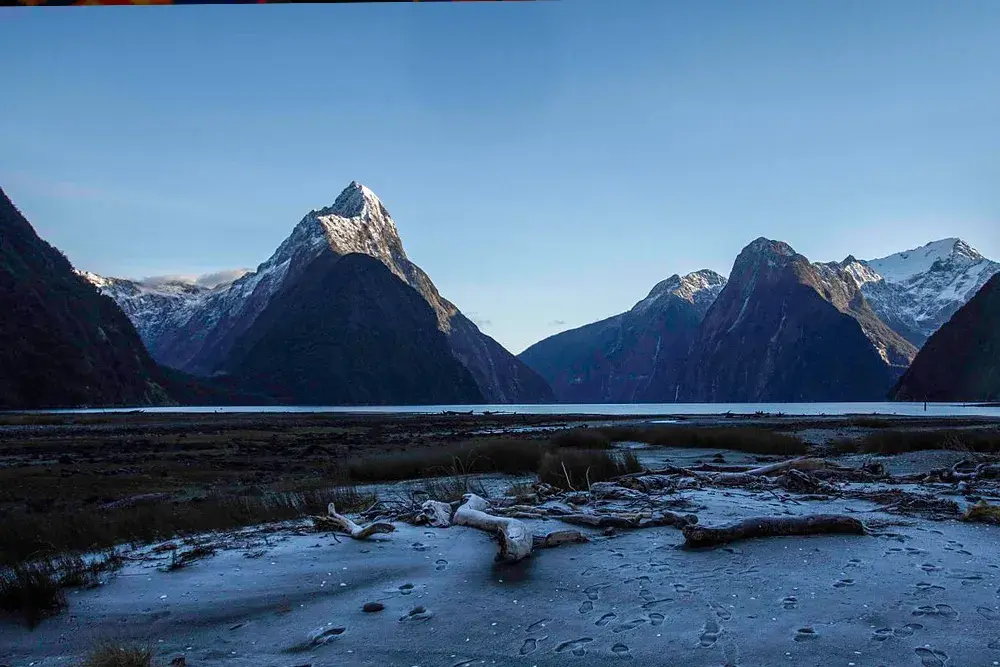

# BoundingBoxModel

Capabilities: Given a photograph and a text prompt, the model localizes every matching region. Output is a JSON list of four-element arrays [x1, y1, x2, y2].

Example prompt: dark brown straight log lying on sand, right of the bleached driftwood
[[682, 514, 865, 547]]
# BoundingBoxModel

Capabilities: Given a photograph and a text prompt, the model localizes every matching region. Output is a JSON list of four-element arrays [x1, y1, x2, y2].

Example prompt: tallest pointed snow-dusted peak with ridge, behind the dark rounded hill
[[89, 182, 553, 403]]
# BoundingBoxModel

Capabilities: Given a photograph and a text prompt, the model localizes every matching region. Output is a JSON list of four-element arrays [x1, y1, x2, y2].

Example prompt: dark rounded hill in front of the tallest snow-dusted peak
[[226, 253, 483, 405]]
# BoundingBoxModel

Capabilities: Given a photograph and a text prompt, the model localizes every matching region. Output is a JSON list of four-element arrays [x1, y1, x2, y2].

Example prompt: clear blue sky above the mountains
[[0, 0, 1000, 352]]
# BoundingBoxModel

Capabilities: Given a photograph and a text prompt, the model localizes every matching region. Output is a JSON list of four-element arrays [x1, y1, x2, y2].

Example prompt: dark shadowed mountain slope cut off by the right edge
[[893, 274, 1000, 401]]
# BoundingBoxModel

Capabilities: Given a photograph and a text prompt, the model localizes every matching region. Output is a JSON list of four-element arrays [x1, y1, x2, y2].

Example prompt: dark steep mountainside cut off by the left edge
[[0, 185, 170, 409]]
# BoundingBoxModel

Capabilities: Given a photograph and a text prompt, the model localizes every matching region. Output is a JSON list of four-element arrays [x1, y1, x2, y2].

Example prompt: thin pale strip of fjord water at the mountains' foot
[[38, 402, 1000, 418]]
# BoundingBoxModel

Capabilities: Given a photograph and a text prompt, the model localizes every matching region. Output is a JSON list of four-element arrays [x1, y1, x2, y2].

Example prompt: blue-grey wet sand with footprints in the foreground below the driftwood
[[0, 470, 1000, 667]]
